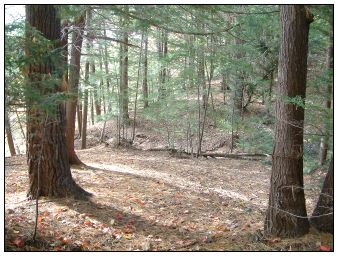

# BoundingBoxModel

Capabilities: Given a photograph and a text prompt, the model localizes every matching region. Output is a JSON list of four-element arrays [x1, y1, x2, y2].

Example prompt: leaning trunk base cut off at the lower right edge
[[310, 158, 333, 234]]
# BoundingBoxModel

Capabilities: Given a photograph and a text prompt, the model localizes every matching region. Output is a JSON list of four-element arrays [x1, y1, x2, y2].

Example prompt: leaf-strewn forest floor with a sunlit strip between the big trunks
[[5, 145, 333, 251]]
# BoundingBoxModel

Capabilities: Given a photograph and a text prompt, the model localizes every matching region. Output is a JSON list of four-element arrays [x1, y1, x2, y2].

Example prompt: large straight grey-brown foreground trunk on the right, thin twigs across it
[[264, 5, 313, 237]]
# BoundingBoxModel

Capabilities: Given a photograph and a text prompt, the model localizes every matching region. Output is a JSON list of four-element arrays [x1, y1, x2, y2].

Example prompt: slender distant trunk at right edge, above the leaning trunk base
[[319, 19, 333, 165]]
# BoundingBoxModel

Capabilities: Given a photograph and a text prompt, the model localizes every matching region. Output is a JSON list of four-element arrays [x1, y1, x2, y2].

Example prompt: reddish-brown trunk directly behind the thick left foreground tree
[[66, 15, 85, 165]]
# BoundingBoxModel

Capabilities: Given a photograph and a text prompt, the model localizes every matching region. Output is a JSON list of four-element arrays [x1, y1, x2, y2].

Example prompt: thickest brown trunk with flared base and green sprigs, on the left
[[25, 5, 89, 198]]
